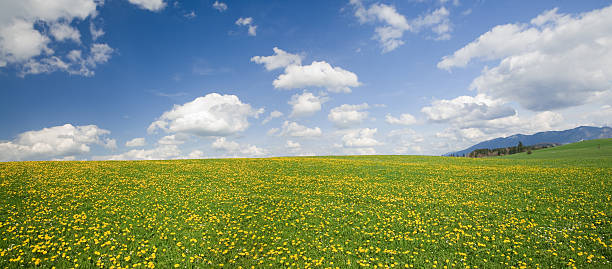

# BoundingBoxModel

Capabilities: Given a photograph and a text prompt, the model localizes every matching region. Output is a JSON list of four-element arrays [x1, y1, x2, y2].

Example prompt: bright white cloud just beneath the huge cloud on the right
[[421, 94, 516, 125]]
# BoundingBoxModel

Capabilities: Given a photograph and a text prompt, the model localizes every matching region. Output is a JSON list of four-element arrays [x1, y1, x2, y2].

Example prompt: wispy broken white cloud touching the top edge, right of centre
[[350, 0, 451, 53]]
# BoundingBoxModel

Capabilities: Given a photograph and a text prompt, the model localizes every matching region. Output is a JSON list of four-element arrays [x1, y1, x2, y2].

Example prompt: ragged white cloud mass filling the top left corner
[[0, 0, 129, 77]]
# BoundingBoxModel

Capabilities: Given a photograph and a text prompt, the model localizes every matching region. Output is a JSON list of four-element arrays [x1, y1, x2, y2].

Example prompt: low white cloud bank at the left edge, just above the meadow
[[0, 124, 116, 161]]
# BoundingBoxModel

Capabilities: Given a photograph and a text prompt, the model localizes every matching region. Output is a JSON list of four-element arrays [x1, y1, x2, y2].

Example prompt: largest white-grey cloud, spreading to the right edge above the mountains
[[438, 6, 612, 111]]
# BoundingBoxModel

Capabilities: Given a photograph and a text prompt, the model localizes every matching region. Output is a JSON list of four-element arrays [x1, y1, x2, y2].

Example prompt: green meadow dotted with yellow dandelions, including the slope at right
[[0, 140, 612, 268]]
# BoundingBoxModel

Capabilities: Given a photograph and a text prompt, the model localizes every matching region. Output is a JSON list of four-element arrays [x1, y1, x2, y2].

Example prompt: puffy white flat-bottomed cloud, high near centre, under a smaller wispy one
[[272, 61, 361, 93]]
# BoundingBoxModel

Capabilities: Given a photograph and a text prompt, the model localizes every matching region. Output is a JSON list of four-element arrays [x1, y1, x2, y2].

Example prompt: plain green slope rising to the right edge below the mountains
[[500, 138, 612, 160]]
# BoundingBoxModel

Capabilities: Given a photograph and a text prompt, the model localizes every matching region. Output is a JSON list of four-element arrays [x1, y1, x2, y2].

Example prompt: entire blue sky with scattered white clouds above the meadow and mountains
[[0, 0, 612, 161]]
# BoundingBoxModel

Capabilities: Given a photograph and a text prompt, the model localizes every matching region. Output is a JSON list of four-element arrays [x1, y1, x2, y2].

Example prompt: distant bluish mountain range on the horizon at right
[[444, 126, 612, 156]]
